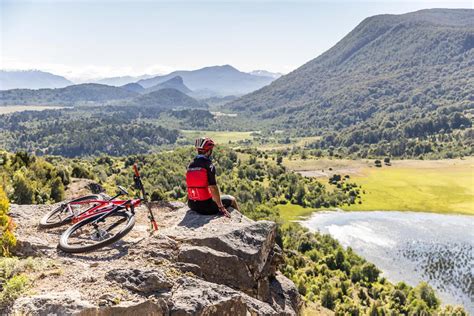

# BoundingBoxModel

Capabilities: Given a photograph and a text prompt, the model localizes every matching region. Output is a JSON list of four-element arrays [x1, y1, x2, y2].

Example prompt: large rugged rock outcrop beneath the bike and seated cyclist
[[8, 203, 301, 316]]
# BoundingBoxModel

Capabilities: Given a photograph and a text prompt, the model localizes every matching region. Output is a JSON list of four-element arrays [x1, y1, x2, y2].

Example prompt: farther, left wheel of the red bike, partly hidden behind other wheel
[[39, 194, 105, 228]]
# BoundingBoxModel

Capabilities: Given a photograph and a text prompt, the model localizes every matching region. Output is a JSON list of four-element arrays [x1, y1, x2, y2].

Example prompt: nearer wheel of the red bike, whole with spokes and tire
[[59, 211, 135, 253]]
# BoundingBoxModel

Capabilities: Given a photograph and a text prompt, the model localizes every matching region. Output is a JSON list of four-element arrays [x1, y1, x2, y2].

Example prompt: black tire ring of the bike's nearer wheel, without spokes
[[58, 211, 135, 253]]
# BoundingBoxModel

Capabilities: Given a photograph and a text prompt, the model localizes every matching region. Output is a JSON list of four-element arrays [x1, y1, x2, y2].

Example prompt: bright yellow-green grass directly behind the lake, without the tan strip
[[343, 165, 474, 215]]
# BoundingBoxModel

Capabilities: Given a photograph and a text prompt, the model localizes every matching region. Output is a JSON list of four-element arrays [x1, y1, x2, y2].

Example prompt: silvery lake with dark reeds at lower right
[[301, 211, 474, 314]]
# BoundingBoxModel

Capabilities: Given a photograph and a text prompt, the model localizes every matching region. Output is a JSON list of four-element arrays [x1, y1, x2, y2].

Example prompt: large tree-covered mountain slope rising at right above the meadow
[[227, 9, 474, 155]]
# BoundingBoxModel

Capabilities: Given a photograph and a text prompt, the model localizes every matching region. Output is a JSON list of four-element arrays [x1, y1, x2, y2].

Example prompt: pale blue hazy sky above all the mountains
[[0, 0, 474, 80]]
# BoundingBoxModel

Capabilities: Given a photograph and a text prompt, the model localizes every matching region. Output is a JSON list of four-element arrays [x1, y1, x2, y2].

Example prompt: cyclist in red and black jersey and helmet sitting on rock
[[186, 137, 238, 217]]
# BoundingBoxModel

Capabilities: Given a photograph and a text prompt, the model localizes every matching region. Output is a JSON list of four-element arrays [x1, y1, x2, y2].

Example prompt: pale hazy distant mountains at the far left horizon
[[0, 70, 73, 90]]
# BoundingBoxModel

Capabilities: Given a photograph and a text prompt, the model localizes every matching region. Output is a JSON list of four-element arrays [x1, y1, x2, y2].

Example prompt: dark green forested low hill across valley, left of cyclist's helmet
[[0, 106, 179, 157]]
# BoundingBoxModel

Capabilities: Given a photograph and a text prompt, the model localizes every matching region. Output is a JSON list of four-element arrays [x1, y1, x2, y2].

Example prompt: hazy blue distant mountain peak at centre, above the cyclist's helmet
[[137, 65, 274, 97]]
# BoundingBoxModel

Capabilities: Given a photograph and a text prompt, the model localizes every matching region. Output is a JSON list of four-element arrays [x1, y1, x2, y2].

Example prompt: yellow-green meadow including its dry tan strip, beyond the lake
[[280, 157, 474, 218]]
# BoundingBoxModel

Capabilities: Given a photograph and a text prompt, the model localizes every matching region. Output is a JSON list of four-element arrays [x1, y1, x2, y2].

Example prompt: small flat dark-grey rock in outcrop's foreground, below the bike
[[105, 269, 173, 294]]
